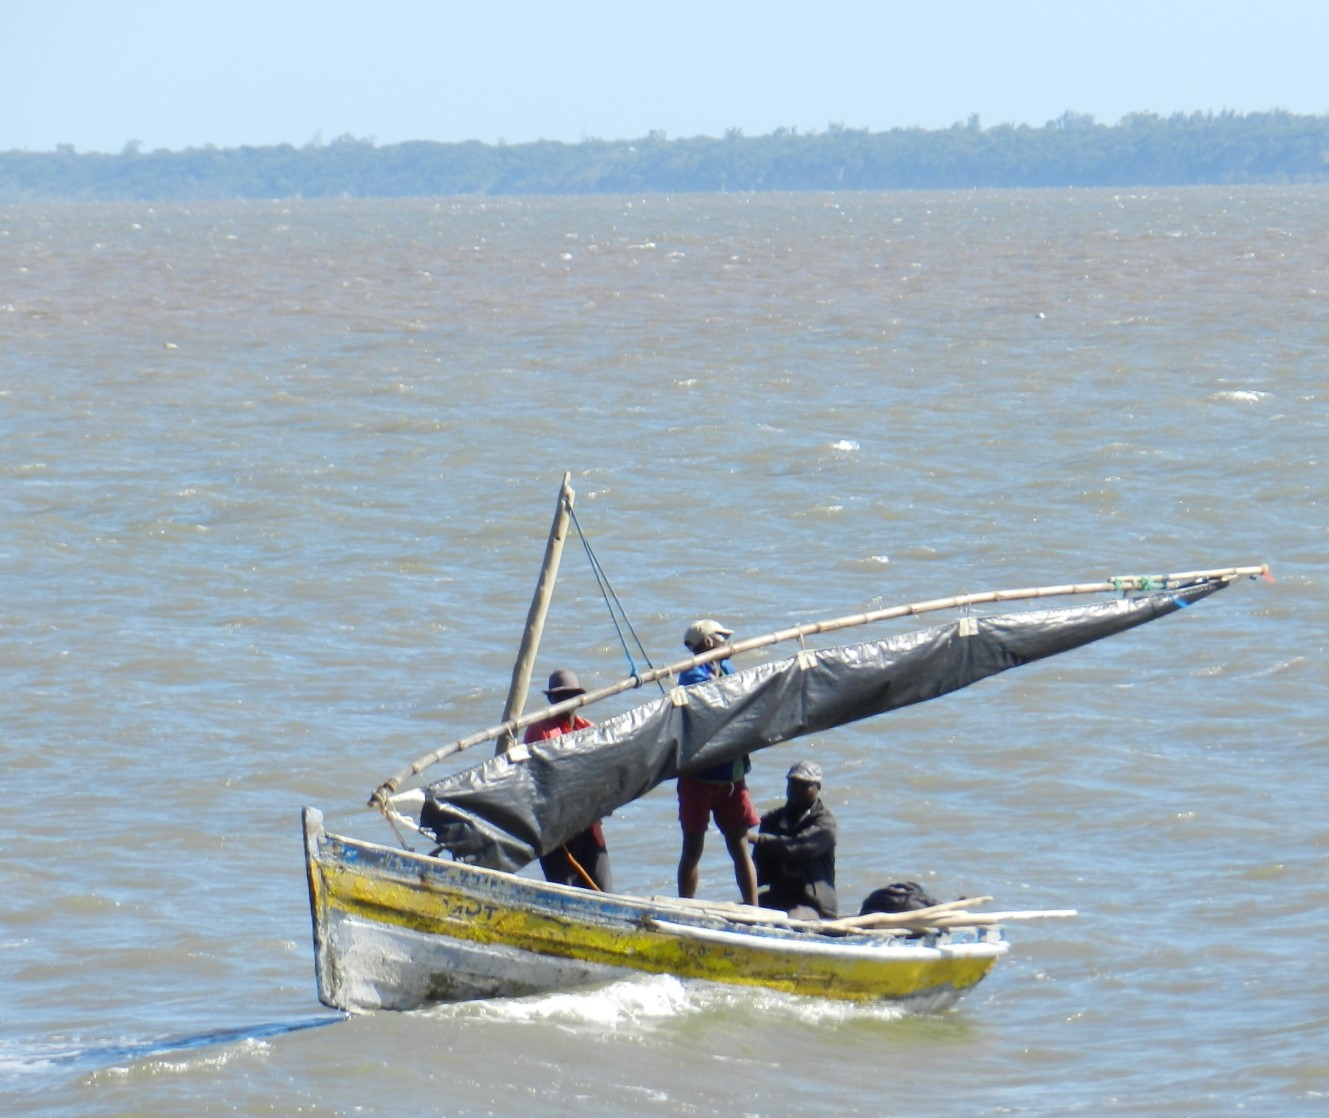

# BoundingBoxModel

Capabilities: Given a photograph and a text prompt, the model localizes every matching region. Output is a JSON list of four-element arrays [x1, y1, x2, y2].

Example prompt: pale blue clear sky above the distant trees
[[0, 0, 1329, 152]]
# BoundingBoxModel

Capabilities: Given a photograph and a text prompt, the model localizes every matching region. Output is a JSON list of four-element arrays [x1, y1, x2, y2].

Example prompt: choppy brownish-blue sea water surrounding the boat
[[0, 187, 1329, 1118]]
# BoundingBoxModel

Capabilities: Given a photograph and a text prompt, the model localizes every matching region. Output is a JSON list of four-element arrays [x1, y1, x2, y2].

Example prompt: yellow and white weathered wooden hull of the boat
[[304, 808, 1007, 1012]]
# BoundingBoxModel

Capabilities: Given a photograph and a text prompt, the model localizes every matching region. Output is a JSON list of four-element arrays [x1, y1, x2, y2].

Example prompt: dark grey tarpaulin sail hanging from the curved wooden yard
[[420, 580, 1227, 872]]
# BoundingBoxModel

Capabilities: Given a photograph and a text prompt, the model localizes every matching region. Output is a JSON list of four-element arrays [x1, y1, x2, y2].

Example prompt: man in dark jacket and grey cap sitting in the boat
[[752, 760, 836, 920]]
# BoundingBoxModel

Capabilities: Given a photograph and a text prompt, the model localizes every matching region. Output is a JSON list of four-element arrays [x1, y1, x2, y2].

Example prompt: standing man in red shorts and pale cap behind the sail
[[678, 617, 760, 904]]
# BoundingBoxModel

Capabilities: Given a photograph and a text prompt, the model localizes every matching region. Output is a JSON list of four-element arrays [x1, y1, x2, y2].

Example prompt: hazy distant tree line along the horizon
[[0, 112, 1329, 202]]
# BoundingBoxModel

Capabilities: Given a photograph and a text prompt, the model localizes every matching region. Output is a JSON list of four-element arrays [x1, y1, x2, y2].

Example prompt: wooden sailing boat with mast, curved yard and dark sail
[[304, 476, 1268, 1010]]
